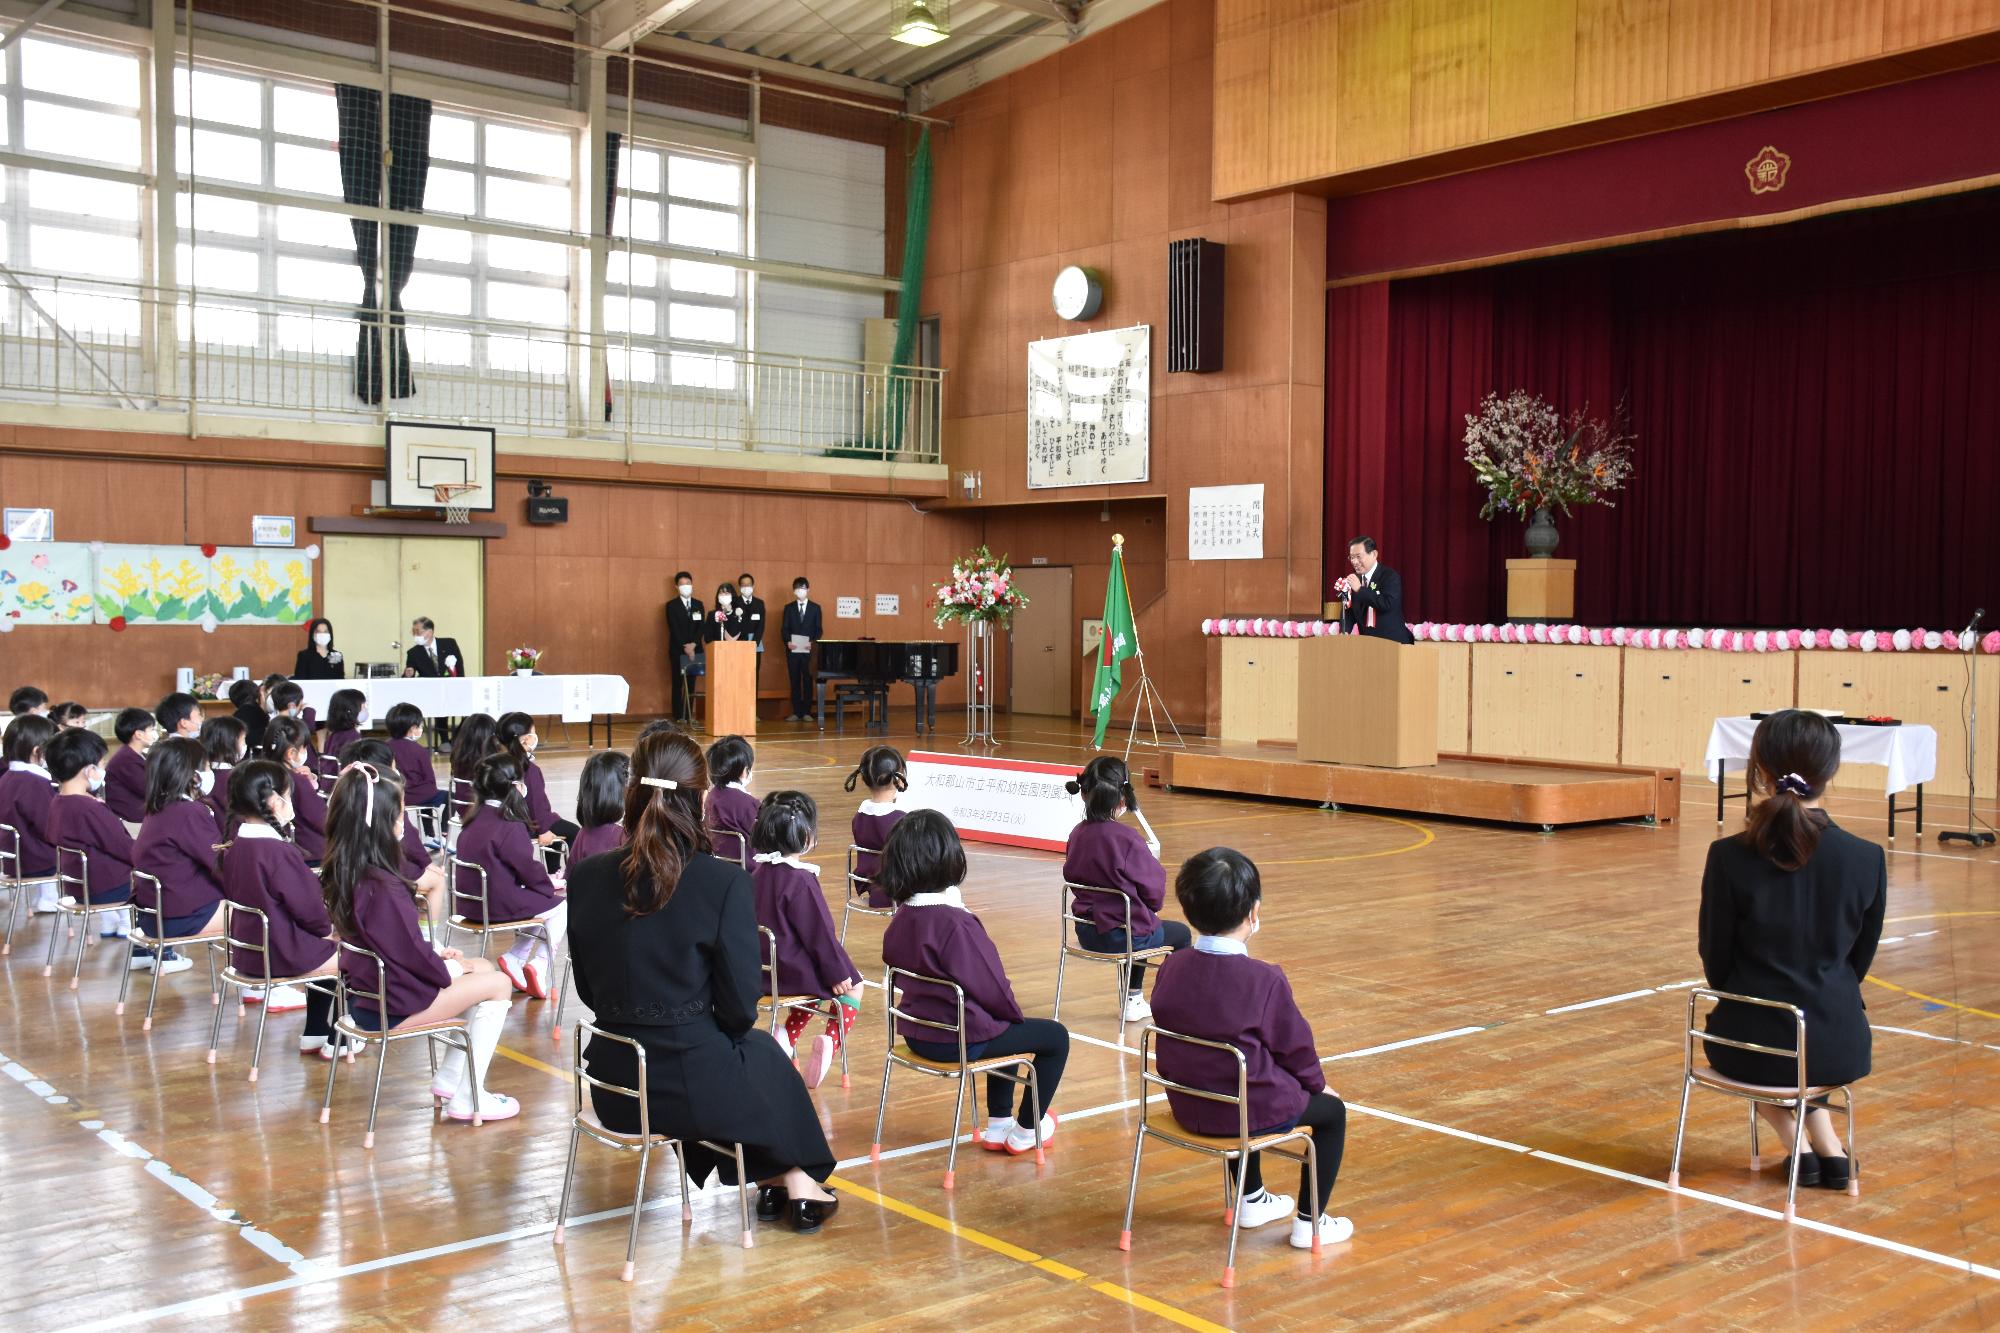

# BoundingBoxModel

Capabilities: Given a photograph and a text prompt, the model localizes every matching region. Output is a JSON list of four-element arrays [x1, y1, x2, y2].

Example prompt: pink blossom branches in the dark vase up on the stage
[[1466, 388, 1634, 520]]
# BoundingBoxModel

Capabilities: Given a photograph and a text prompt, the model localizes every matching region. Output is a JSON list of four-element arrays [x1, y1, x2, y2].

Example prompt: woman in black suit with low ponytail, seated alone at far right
[[1700, 709, 1888, 1189]]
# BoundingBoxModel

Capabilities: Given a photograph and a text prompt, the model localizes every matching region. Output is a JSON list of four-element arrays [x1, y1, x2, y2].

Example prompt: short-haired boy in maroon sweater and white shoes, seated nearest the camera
[[1152, 847, 1354, 1249]]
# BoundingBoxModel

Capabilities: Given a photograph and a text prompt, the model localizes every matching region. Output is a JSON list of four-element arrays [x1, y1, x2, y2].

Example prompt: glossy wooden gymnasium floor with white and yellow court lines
[[0, 715, 2000, 1329]]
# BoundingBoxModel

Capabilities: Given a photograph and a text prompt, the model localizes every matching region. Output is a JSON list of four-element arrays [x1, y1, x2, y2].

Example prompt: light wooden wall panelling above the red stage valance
[[1210, 0, 2000, 198]]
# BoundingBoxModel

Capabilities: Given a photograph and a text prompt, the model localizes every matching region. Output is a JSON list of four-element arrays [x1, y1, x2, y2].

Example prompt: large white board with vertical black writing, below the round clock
[[1028, 324, 1152, 488]]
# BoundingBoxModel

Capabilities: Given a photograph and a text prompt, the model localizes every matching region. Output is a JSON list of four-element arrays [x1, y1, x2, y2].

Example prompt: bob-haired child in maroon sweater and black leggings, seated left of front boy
[[882, 811, 1070, 1157]]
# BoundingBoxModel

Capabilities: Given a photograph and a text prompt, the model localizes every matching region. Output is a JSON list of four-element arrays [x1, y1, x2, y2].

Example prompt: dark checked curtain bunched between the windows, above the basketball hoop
[[334, 84, 430, 402]]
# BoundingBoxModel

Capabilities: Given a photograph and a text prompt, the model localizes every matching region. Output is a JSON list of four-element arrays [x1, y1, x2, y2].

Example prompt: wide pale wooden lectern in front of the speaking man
[[1298, 634, 1438, 769]]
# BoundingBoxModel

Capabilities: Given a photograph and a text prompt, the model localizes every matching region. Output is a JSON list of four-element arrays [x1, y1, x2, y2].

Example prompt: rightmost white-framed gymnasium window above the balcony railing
[[604, 142, 748, 378]]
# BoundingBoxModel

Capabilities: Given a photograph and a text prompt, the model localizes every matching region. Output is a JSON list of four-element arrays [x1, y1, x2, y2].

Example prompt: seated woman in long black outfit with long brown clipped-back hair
[[568, 727, 840, 1231]]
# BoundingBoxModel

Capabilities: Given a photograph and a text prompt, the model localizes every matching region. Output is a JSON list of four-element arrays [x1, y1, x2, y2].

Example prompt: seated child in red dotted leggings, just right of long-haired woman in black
[[750, 791, 862, 1087]]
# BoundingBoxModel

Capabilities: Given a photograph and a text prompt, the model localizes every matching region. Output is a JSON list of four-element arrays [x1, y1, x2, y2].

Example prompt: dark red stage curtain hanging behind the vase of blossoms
[[1326, 192, 2000, 628]]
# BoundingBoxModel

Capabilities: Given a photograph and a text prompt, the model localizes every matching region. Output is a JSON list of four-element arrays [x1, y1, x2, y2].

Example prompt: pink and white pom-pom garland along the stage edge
[[1202, 616, 2000, 652]]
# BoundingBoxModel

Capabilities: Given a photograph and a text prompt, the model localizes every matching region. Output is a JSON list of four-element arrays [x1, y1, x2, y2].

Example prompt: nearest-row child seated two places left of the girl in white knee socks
[[132, 737, 222, 973]]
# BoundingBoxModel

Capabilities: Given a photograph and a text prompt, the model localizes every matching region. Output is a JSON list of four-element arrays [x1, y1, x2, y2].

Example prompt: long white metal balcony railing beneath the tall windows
[[0, 268, 944, 462]]
